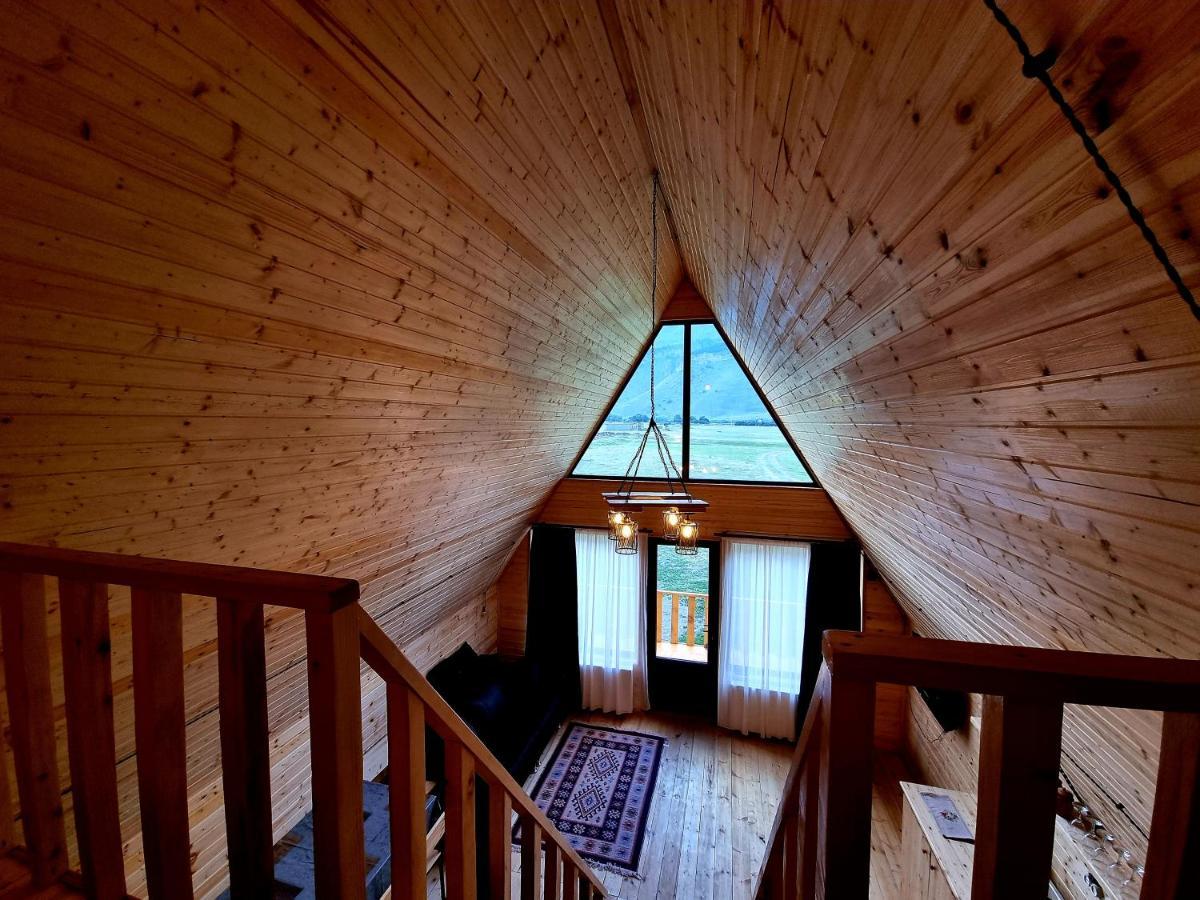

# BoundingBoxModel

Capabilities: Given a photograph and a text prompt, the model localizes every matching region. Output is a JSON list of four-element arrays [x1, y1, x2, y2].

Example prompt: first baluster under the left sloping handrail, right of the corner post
[[388, 682, 426, 899]]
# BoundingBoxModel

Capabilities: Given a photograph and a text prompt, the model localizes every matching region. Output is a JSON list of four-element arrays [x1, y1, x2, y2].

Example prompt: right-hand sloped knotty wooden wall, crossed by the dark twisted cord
[[619, 0, 1200, 873]]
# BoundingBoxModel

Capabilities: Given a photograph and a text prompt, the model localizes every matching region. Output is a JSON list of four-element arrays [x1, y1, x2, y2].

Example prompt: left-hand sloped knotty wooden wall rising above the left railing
[[0, 0, 680, 892]]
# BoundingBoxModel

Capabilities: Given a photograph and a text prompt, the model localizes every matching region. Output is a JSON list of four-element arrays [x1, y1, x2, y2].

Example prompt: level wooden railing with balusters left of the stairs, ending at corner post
[[0, 542, 366, 900]]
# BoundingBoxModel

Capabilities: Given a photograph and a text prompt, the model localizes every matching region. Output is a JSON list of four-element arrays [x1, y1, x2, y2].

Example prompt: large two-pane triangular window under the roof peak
[[571, 323, 812, 485]]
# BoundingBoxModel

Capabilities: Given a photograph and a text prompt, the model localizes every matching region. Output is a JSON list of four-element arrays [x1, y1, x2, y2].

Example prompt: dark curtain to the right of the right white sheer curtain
[[796, 541, 863, 734]]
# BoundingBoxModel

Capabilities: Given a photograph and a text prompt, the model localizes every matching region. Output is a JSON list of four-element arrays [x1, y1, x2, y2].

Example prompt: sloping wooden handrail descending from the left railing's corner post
[[359, 610, 606, 896]]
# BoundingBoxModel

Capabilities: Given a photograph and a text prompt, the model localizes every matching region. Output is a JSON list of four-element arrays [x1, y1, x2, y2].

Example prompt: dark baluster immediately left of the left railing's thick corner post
[[217, 598, 275, 900]]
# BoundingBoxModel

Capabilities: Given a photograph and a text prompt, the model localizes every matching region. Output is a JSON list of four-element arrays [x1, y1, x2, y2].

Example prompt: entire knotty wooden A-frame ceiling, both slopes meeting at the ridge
[[0, 0, 1200, 883]]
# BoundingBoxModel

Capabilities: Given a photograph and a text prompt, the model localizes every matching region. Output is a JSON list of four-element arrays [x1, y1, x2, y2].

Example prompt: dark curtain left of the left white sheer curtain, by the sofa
[[526, 524, 583, 709]]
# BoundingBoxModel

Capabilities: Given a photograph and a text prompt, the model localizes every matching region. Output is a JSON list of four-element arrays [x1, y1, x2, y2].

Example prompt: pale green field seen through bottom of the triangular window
[[575, 422, 811, 484]]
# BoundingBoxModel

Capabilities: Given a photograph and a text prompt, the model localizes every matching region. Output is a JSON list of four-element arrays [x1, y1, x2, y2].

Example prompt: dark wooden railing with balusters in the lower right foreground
[[756, 631, 1200, 900]]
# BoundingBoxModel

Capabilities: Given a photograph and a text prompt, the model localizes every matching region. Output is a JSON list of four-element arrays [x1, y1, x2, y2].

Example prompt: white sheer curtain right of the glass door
[[716, 538, 809, 740]]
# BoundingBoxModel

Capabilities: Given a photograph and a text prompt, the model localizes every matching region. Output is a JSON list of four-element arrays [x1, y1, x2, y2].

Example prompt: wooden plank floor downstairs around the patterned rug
[[430, 712, 905, 900]]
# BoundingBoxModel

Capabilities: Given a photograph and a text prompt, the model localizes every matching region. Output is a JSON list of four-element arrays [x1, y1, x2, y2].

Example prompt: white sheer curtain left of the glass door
[[575, 528, 649, 713]]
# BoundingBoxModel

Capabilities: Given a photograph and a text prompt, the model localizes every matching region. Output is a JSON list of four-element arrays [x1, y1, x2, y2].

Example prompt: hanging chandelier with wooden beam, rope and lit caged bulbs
[[602, 172, 708, 556]]
